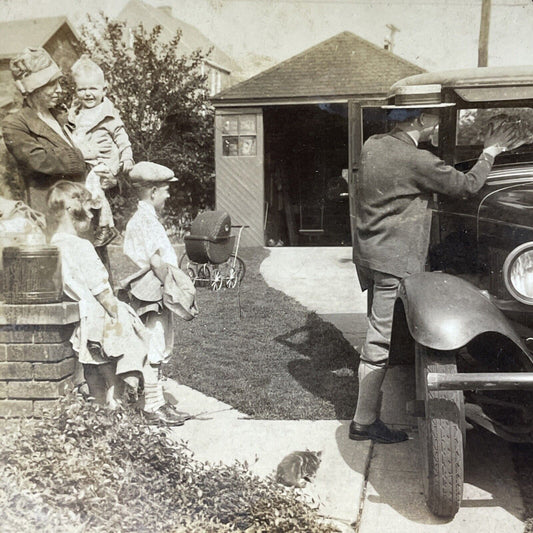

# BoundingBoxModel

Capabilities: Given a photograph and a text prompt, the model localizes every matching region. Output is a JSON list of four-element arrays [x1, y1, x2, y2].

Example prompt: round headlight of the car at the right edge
[[502, 242, 533, 305]]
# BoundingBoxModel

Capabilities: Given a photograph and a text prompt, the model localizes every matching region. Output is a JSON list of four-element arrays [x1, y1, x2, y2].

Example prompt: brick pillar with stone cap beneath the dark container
[[0, 302, 79, 417]]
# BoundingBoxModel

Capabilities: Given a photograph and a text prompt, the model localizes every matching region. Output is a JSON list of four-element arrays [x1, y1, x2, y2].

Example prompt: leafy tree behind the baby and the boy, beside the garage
[[68, 15, 214, 230]]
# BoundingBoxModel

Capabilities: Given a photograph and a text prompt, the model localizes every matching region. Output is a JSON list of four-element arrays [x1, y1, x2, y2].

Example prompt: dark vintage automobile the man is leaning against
[[351, 67, 533, 517]]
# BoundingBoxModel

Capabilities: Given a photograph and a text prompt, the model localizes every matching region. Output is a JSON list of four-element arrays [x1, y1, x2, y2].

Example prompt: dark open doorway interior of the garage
[[263, 104, 351, 246]]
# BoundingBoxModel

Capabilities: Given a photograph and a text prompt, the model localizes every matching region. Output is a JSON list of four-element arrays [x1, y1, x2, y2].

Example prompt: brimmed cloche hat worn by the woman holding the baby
[[9, 47, 63, 95]]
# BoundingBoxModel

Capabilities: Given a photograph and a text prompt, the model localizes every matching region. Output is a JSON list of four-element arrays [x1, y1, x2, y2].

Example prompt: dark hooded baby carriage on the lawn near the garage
[[179, 211, 247, 291]]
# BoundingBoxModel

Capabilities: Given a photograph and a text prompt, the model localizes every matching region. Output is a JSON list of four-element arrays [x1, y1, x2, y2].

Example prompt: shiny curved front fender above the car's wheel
[[395, 272, 527, 353]]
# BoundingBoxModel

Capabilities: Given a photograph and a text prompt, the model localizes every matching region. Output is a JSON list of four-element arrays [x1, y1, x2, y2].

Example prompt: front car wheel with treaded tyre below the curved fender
[[415, 343, 464, 517]]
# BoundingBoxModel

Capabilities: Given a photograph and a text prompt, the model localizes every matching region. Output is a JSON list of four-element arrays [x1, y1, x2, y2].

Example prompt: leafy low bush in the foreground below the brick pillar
[[0, 397, 334, 533]]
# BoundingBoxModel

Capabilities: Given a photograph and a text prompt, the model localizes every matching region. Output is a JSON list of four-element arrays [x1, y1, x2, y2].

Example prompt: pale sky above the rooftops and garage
[[0, 0, 533, 75]]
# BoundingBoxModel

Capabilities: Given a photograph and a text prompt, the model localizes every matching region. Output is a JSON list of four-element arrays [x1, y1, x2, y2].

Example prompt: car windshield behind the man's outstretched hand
[[455, 107, 533, 163]]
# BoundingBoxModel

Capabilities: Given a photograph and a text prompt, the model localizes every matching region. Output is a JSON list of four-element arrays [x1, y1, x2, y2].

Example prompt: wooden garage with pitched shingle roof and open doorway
[[212, 32, 423, 246]]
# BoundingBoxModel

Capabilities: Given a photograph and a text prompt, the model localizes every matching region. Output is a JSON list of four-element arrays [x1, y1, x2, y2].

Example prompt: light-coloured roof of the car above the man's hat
[[390, 65, 533, 102]]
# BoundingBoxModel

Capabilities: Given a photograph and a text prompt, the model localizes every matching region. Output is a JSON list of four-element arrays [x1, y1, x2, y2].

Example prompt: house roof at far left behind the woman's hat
[[0, 17, 79, 59]]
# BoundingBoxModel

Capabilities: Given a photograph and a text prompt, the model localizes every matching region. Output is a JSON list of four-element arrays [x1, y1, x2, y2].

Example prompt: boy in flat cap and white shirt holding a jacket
[[124, 161, 197, 380]]
